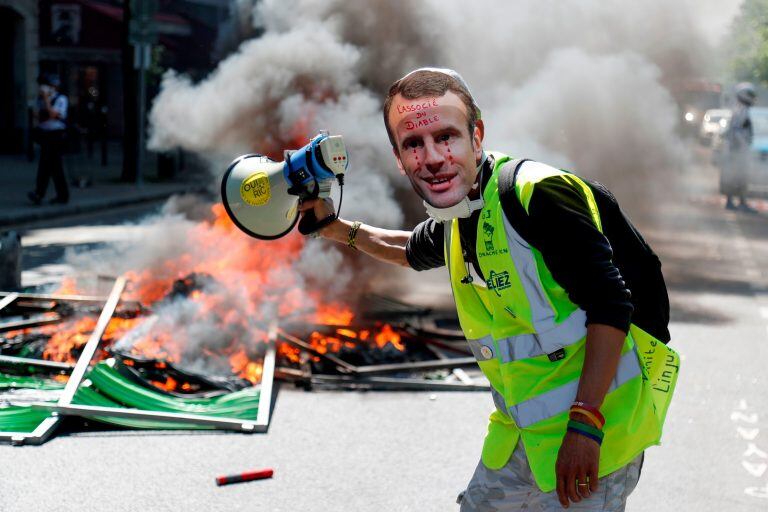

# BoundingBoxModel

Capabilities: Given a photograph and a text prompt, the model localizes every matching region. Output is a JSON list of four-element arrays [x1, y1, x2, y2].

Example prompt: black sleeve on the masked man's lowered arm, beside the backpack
[[528, 176, 633, 332]]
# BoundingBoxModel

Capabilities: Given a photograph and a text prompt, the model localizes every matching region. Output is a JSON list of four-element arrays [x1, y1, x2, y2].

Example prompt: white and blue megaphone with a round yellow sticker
[[221, 132, 349, 240]]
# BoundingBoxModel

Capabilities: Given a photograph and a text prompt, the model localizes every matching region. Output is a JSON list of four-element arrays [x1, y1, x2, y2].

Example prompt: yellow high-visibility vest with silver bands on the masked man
[[445, 153, 680, 492]]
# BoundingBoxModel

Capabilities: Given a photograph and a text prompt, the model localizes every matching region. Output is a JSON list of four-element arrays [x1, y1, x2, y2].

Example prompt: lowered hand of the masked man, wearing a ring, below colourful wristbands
[[555, 432, 600, 508]]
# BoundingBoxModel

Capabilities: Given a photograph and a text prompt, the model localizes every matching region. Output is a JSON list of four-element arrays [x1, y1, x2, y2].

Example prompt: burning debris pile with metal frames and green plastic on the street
[[0, 206, 487, 443]]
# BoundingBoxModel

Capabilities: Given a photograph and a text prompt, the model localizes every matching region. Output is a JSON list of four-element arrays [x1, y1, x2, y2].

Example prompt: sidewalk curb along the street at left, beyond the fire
[[0, 185, 206, 227]]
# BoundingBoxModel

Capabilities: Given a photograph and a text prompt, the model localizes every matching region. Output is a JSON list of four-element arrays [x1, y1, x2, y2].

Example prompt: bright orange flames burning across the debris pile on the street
[[6, 196, 405, 391]]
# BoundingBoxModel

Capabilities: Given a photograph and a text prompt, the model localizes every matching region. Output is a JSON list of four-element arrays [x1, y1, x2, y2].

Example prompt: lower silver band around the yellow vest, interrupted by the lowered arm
[[508, 348, 640, 428]]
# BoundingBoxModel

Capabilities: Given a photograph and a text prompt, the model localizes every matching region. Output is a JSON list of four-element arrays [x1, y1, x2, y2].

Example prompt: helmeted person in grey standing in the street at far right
[[720, 82, 757, 213]]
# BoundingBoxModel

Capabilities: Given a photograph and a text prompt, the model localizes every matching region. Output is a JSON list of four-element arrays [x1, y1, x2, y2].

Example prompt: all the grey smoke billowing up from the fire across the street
[[61, 0, 734, 374]]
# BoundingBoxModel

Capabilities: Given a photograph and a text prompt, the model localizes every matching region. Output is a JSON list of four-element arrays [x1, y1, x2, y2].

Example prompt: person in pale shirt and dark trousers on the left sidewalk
[[27, 75, 69, 205]]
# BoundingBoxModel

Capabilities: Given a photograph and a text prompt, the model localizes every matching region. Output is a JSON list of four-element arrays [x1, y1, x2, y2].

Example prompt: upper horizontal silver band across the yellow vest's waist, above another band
[[498, 309, 587, 363]]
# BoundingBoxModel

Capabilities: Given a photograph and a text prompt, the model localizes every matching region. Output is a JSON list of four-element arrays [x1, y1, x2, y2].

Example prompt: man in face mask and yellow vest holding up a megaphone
[[301, 68, 674, 511]]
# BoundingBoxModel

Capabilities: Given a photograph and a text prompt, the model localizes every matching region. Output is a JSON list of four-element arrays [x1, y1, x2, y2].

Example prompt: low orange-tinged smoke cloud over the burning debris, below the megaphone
[[67, 204, 352, 375]]
